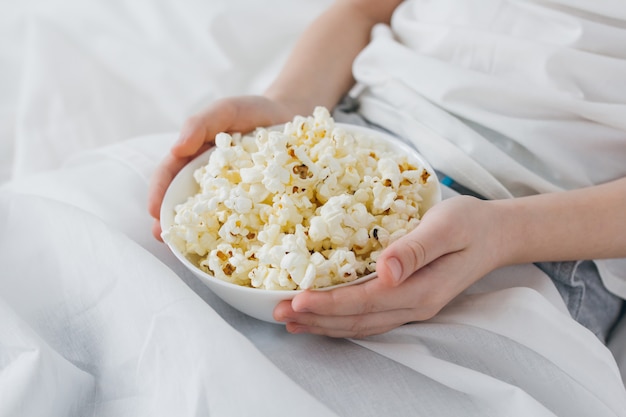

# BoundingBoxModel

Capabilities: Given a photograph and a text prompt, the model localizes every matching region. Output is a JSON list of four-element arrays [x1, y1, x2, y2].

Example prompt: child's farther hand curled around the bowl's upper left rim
[[148, 96, 294, 240]]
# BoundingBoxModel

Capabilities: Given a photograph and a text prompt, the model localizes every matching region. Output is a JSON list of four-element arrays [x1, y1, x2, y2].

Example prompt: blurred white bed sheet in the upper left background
[[0, 0, 330, 184]]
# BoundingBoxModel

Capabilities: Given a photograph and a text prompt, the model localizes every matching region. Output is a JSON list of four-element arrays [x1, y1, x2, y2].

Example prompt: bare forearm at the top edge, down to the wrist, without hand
[[265, 0, 401, 114]]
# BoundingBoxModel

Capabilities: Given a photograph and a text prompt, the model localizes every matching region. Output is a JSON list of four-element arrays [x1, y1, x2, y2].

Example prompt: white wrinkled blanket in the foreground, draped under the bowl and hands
[[0, 134, 626, 417]]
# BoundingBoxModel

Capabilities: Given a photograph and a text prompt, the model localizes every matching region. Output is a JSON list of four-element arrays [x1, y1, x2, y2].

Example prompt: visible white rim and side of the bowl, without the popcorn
[[160, 123, 441, 323]]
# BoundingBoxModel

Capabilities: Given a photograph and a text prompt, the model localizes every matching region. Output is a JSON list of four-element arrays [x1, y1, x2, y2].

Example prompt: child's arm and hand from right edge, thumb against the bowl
[[274, 178, 626, 337]]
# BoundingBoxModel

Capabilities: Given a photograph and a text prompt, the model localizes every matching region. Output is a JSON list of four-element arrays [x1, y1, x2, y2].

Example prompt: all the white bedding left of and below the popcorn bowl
[[0, 0, 626, 417]]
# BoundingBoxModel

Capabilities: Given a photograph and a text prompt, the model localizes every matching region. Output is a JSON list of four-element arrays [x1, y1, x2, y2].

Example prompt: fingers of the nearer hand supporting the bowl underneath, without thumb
[[274, 253, 475, 337]]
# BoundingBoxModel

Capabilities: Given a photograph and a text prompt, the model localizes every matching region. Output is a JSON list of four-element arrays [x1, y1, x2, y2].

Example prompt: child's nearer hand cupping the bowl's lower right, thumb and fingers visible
[[274, 197, 502, 338]]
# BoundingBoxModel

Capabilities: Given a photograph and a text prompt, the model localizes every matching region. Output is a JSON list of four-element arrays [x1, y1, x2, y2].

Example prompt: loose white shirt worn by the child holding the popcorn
[[354, 0, 626, 298]]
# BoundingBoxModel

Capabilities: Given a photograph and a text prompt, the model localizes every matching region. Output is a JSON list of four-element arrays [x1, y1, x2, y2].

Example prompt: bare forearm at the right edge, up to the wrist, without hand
[[490, 178, 626, 264]]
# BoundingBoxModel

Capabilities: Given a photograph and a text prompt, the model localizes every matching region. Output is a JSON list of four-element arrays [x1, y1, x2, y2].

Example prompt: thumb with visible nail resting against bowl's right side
[[376, 213, 461, 286]]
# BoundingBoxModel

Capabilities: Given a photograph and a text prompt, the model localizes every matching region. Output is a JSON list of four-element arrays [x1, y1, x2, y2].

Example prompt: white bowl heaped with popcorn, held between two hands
[[161, 107, 441, 322]]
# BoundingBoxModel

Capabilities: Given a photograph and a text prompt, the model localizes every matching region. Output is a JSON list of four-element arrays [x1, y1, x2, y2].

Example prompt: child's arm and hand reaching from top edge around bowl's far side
[[148, 0, 401, 239]]
